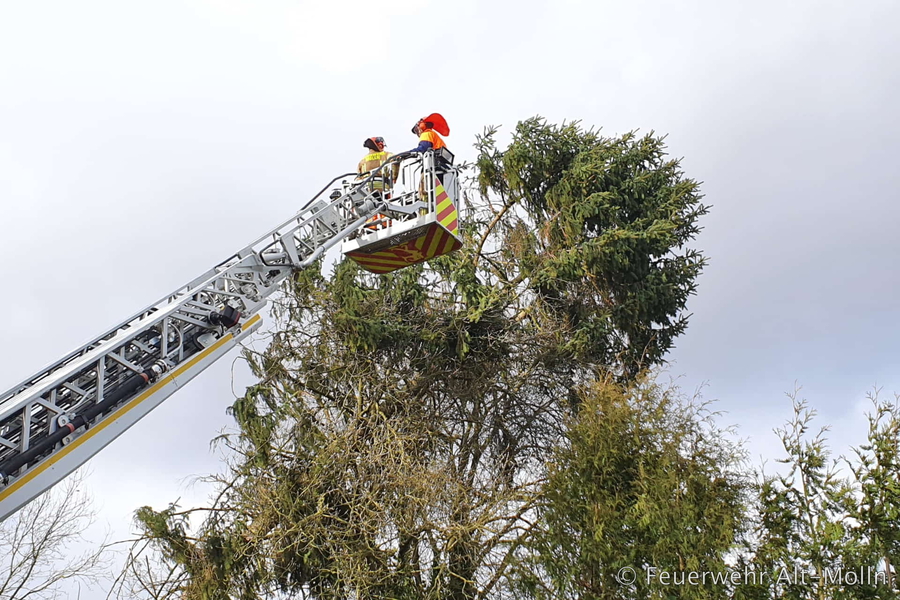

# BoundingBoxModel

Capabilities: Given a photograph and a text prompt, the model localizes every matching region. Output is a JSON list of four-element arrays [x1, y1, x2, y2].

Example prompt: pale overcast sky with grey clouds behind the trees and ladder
[[0, 0, 900, 597]]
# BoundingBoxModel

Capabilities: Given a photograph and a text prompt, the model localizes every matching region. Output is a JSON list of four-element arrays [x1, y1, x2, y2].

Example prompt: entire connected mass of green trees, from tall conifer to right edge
[[123, 118, 900, 600]]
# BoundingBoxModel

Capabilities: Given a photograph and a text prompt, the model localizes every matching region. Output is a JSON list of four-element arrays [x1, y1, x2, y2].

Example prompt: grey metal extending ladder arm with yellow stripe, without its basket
[[0, 156, 448, 521]]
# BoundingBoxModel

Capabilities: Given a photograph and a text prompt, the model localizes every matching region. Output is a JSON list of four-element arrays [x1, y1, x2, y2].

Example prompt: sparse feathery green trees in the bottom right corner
[[735, 393, 900, 600]]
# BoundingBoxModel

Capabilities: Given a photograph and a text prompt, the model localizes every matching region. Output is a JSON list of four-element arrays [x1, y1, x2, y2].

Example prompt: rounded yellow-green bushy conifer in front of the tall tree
[[521, 381, 745, 600]]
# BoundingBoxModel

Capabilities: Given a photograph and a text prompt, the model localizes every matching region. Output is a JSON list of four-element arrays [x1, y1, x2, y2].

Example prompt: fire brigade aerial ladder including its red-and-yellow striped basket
[[0, 148, 461, 521]]
